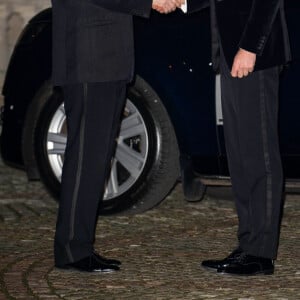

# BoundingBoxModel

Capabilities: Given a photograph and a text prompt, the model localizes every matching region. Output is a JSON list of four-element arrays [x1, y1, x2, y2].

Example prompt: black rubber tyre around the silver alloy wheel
[[23, 77, 179, 214]]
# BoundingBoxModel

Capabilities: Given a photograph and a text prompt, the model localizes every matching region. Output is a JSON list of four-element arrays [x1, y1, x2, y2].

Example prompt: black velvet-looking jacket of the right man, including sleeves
[[187, 0, 291, 70]]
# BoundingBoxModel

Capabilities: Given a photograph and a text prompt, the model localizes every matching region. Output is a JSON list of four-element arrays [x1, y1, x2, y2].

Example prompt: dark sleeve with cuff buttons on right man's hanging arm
[[239, 0, 283, 56]]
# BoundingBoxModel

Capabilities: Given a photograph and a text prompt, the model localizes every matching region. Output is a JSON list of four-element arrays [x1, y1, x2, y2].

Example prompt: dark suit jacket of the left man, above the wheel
[[52, 0, 152, 85]]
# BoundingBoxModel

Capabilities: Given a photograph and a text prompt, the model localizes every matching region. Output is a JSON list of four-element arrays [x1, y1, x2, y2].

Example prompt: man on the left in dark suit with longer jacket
[[52, 0, 181, 272]]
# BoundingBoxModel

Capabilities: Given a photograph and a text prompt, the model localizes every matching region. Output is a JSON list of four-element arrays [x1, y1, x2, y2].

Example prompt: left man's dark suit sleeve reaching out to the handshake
[[76, 0, 152, 18]]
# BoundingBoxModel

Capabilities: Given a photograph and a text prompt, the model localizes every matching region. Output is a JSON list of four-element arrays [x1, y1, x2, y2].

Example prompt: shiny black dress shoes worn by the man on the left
[[56, 253, 120, 273]]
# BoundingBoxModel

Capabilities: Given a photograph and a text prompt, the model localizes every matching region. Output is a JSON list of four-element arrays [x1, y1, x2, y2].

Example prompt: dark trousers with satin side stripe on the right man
[[221, 55, 283, 259]]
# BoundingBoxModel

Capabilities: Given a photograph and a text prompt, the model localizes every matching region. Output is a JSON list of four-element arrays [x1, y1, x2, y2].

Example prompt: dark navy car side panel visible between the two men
[[135, 9, 219, 175]]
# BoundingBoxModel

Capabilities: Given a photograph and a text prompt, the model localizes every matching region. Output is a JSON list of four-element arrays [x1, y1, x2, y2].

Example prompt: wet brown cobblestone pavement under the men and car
[[0, 158, 300, 300]]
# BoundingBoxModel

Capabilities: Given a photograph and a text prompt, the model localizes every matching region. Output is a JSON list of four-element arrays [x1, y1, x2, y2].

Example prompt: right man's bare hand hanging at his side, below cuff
[[231, 49, 256, 78]]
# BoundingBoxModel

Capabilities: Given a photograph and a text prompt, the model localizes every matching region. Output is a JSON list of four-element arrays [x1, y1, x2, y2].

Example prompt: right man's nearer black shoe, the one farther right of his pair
[[218, 253, 274, 276]]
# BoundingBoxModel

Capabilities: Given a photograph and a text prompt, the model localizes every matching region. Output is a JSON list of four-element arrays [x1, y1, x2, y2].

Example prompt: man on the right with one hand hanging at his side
[[187, 0, 291, 275]]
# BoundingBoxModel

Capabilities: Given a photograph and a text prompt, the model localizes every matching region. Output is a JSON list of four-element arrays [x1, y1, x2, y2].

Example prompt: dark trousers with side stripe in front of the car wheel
[[54, 81, 126, 266]]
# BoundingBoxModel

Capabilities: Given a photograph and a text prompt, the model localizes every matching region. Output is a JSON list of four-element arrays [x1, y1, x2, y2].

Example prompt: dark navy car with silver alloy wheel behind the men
[[1, 0, 300, 213]]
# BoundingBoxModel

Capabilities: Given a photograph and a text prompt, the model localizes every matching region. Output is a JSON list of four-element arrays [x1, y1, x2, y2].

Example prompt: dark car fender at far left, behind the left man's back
[[1, 9, 51, 167]]
